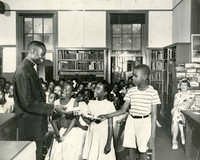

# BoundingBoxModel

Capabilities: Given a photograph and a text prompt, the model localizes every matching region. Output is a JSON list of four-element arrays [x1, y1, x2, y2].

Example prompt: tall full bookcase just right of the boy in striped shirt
[[149, 47, 176, 119]]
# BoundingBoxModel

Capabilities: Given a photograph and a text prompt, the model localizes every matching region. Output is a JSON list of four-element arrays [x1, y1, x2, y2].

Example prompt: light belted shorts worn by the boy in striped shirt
[[123, 115, 151, 152]]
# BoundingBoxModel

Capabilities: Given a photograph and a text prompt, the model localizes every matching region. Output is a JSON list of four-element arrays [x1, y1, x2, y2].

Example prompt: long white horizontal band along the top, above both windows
[[2, 0, 172, 10]]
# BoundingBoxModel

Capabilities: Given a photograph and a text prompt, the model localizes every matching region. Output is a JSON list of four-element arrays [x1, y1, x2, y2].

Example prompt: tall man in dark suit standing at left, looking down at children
[[13, 41, 60, 160]]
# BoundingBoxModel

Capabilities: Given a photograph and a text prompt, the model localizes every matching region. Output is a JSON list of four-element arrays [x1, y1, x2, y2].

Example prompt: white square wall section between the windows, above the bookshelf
[[58, 11, 106, 47]]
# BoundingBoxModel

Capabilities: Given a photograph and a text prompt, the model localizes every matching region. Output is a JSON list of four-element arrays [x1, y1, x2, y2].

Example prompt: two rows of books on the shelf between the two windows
[[57, 49, 104, 72]]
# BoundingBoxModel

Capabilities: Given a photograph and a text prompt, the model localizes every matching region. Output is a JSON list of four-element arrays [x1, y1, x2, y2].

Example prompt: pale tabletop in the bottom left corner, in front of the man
[[0, 141, 36, 160]]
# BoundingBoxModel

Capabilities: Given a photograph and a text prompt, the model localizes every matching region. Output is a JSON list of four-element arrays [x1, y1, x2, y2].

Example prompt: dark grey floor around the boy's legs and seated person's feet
[[118, 127, 186, 160]]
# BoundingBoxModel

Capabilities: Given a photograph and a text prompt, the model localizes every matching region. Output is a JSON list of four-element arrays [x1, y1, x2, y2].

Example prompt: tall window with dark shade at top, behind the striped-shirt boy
[[110, 13, 145, 82]]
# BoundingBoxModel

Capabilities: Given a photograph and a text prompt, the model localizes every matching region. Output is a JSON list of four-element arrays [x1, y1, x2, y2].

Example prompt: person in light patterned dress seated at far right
[[171, 79, 195, 150]]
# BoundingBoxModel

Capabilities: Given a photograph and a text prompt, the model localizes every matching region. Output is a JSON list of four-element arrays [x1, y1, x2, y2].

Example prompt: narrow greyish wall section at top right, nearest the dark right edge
[[172, 0, 191, 43]]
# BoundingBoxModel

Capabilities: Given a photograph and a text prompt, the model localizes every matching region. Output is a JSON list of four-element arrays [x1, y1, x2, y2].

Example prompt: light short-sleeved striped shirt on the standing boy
[[124, 85, 160, 116]]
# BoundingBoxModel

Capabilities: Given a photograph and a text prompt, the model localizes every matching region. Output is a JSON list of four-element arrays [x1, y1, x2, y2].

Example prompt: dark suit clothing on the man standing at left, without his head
[[13, 59, 53, 140]]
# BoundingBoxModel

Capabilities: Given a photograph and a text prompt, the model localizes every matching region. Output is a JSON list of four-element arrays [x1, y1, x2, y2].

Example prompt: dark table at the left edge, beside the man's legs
[[0, 113, 18, 140]]
